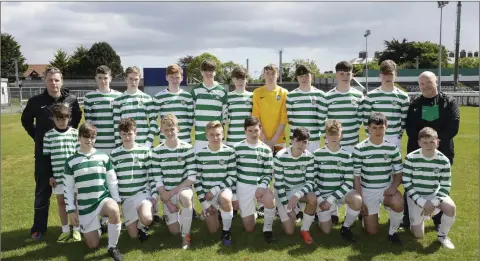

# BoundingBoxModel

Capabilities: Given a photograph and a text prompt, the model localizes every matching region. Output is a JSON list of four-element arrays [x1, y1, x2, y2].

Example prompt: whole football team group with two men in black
[[21, 60, 460, 261]]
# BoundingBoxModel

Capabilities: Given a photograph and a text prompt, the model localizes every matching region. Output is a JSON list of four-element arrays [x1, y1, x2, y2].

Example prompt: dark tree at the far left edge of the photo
[[1, 33, 28, 81]]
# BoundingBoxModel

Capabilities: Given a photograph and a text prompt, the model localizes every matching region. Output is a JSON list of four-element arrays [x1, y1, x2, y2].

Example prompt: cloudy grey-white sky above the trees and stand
[[1, 2, 480, 76]]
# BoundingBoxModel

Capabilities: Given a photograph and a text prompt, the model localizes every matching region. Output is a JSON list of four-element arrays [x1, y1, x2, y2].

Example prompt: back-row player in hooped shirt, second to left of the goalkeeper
[[192, 60, 228, 152]]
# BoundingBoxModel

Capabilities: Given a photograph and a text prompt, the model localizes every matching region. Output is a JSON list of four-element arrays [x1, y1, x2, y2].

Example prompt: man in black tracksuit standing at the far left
[[22, 68, 82, 239]]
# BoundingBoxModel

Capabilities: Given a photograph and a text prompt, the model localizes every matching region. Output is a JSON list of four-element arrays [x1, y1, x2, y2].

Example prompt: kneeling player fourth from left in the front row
[[195, 121, 237, 246]]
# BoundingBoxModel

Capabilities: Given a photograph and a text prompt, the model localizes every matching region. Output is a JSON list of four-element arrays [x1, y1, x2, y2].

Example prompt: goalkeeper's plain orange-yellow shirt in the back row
[[252, 85, 288, 144]]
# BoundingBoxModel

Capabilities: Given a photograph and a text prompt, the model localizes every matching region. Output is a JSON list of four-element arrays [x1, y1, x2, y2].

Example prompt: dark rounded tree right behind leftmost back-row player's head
[[87, 42, 123, 78]]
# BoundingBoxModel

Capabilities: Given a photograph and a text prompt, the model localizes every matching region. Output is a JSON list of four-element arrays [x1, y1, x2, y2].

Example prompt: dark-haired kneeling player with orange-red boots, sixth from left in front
[[273, 127, 317, 244]]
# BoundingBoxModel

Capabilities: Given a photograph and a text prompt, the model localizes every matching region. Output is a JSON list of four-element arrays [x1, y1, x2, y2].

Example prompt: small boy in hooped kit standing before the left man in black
[[43, 103, 82, 243]]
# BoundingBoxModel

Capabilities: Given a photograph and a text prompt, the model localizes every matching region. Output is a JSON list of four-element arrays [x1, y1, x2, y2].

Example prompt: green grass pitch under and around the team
[[1, 107, 479, 261]]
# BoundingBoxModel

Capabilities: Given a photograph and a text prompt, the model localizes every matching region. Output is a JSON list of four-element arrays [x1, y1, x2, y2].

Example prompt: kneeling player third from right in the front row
[[314, 120, 362, 242]]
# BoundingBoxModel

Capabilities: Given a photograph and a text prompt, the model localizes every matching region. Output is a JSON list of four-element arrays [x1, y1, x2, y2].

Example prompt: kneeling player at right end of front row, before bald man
[[403, 127, 456, 249]]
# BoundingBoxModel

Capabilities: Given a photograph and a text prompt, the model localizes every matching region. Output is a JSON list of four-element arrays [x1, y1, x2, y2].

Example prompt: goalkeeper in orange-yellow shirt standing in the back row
[[252, 64, 288, 154]]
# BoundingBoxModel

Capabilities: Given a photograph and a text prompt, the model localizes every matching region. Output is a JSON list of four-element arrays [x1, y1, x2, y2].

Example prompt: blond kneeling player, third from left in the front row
[[150, 114, 197, 249]]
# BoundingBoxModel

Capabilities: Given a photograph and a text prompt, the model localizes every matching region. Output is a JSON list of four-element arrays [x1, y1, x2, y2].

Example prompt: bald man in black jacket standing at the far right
[[403, 71, 460, 228]]
